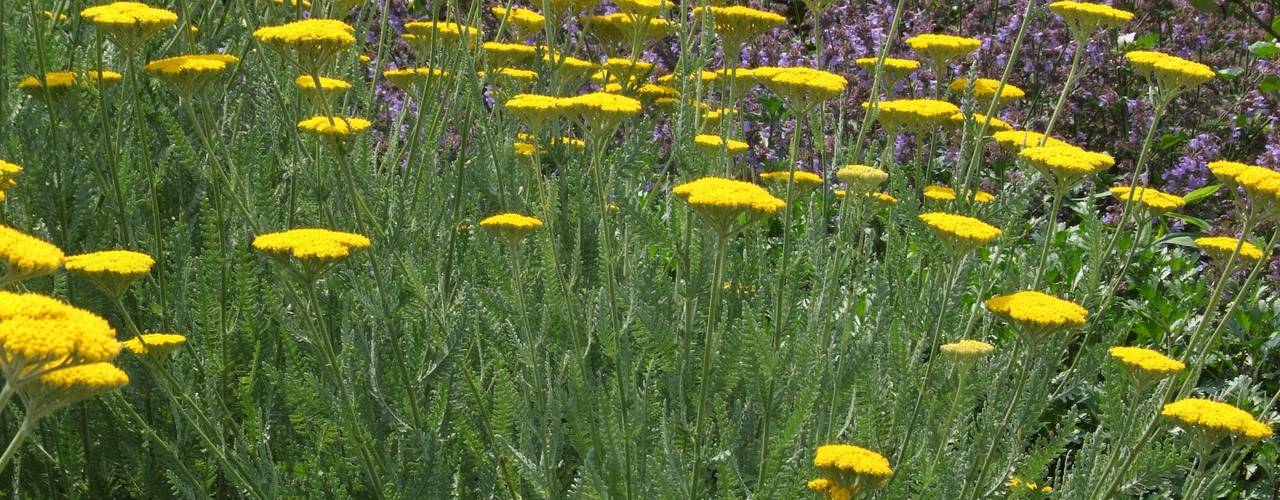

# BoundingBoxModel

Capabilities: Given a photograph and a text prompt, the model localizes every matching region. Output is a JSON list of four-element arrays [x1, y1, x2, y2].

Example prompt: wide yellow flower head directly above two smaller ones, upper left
[[253, 19, 356, 73]]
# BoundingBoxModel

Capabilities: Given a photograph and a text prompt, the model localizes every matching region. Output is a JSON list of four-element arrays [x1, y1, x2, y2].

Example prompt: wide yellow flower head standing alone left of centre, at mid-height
[[253, 228, 371, 279]]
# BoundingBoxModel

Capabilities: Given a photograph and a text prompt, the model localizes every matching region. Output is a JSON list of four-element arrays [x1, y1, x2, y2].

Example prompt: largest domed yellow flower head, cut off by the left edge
[[0, 292, 120, 378]]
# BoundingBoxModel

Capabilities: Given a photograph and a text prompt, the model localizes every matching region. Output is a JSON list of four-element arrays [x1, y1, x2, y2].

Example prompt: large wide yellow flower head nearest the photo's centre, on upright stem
[[671, 176, 787, 235]]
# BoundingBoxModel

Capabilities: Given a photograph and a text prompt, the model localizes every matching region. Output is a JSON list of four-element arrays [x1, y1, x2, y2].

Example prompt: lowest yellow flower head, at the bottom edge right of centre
[[808, 444, 893, 499]]
